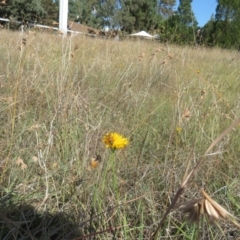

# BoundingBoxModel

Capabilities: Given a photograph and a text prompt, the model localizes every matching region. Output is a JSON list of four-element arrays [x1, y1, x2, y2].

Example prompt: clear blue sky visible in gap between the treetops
[[177, 0, 217, 27]]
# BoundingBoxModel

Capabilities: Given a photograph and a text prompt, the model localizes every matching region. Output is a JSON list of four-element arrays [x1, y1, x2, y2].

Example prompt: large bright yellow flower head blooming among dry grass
[[103, 132, 129, 149]]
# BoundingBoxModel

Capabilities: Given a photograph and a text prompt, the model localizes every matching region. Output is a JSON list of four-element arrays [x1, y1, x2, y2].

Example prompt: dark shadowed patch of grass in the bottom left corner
[[1, 202, 81, 239]]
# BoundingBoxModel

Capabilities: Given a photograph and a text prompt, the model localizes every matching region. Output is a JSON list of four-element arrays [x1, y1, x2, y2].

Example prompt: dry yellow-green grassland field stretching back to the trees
[[0, 31, 240, 239]]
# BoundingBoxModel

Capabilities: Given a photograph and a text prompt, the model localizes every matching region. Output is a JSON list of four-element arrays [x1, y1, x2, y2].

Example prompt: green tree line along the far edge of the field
[[0, 0, 240, 48]]
